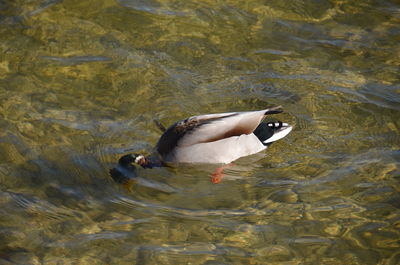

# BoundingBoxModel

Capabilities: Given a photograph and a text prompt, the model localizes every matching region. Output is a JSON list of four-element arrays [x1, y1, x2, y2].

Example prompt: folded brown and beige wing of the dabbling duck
[[156, 106, 282, 156]]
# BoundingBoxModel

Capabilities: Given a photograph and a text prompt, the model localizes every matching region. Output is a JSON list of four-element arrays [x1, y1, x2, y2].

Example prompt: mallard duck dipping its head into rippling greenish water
[[109, 106, 293, 182]]
